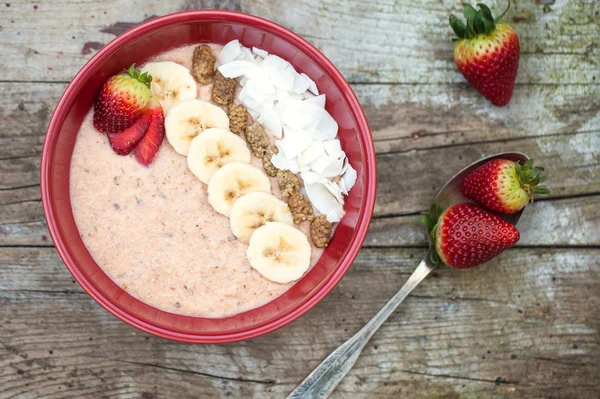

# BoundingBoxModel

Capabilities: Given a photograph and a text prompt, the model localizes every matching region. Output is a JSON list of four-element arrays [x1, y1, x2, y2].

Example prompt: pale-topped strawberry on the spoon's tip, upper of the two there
[[460, 159, 550, 213]]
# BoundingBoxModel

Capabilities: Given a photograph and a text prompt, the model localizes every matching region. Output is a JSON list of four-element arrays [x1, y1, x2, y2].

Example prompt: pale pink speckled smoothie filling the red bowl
[[70, 46, 323, 317]]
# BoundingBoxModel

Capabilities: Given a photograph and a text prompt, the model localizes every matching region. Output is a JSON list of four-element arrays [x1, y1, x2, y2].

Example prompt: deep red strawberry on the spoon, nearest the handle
[[421, 204, 519, 269]]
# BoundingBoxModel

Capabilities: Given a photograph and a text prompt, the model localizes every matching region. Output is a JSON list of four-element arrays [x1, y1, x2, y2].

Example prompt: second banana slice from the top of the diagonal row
[[165, 100, 229, 155]]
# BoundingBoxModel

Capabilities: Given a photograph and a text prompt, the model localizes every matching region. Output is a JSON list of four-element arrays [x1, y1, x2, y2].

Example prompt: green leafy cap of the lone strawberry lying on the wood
[[450, 0, 510, 39]]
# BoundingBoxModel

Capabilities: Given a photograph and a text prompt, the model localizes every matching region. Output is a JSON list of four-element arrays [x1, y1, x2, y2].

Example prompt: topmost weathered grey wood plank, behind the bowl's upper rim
[[0, 0, 600, 84]]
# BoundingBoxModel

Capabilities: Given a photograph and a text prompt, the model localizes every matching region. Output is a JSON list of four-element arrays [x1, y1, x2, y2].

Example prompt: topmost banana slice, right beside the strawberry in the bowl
[[142, 61, 198, 112]]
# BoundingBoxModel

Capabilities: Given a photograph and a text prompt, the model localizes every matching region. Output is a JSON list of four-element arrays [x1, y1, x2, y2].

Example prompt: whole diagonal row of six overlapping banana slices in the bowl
[[147, 62, 311, 283]]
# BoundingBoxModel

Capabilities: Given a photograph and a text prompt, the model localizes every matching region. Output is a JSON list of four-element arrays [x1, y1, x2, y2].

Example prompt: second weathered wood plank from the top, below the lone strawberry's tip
[[0, 83, 600, 159]]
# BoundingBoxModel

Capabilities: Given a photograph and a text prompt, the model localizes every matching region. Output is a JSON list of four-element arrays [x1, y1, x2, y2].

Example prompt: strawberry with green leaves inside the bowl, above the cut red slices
[[94, 65, 152, 133]]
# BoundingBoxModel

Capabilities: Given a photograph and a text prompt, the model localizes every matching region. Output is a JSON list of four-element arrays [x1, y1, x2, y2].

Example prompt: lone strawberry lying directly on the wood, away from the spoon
[[450, 2, 520, 107]]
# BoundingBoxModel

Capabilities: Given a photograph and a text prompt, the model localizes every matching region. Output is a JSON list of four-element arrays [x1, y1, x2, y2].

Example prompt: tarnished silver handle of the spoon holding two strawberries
[[287, 259, 435, 399]]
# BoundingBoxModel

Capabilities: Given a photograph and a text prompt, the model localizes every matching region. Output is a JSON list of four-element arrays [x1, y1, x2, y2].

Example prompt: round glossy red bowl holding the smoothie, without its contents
[[41, 11, 376, 343]]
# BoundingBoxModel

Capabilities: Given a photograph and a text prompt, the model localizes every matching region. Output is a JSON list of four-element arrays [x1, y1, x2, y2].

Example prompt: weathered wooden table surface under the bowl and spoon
[[0, 0, 600, 399]]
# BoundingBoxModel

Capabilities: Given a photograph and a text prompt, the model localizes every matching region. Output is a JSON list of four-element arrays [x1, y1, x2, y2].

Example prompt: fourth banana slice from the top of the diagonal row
[[207, 162, 271, 217]]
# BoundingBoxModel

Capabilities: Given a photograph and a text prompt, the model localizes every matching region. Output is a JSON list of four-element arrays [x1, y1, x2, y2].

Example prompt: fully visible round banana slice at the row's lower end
[[246, 222, 311, 284]]
